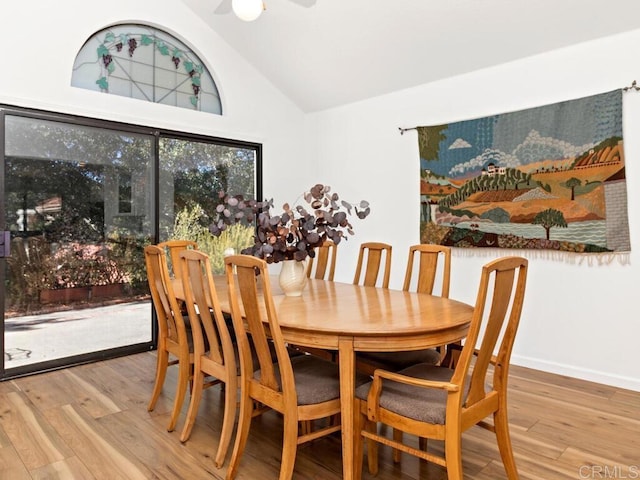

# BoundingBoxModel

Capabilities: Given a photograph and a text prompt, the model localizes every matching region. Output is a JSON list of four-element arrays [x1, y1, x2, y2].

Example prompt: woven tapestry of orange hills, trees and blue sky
[[416, 90, 630, 253]]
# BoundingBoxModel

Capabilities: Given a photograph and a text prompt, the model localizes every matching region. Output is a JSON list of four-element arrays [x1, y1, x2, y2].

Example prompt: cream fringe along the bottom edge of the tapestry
[[451, 247, 631, 267]]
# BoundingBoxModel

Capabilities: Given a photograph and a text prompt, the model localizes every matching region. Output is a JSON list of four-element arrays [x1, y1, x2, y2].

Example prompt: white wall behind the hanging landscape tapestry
[[307, 31, 640, 390]]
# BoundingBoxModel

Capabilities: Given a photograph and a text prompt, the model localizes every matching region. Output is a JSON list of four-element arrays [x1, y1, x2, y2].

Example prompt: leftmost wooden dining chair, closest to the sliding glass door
[[144, 245, 193, 432]]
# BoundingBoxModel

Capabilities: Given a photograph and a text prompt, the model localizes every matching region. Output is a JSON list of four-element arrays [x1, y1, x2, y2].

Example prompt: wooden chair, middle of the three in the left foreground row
[[177, 250, 239, 468]]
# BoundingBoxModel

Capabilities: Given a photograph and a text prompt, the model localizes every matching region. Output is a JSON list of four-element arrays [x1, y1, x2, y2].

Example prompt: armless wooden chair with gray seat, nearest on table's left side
[[225, 255, 367, 480]]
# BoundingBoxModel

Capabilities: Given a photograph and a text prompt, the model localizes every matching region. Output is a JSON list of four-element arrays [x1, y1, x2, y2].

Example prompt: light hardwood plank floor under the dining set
[[0, 352, 640, 480]]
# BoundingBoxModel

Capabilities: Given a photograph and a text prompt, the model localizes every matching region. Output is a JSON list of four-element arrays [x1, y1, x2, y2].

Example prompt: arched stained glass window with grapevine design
[[71, 24, 222, 115]]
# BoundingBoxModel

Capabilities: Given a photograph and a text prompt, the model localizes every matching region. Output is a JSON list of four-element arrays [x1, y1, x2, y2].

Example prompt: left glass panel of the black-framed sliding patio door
[[3, 115, 155, 376]]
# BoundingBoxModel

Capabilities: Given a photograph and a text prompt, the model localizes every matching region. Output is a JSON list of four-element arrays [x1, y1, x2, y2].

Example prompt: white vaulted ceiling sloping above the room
[[181, 0, 640, 112]]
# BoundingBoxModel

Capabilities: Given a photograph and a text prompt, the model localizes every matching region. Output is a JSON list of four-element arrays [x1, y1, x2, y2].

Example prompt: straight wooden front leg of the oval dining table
[[338, 338, 356, 480]]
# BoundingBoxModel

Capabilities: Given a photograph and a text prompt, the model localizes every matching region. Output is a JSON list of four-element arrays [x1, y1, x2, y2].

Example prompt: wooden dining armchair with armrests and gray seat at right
[[354, 257, 528, 480]]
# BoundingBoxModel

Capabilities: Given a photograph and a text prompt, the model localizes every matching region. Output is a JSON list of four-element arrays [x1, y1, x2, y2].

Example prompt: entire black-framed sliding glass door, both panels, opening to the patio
[[0, 107, 261, 379]]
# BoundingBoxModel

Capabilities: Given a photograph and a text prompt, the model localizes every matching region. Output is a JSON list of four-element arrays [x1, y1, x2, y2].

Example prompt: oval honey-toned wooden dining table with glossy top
[[175, 275, 473, 480]]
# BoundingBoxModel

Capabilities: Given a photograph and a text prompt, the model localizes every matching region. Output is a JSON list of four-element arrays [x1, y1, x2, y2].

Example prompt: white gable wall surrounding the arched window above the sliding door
[[0, 0, 310, 202]]
